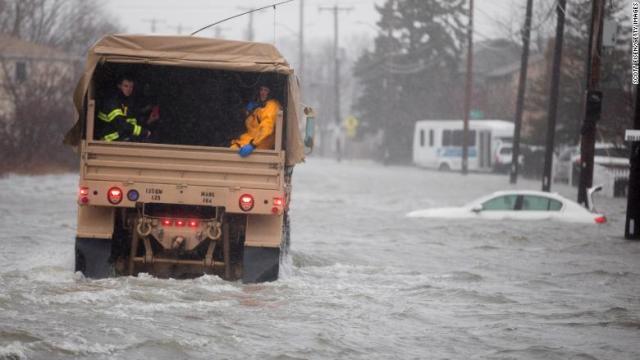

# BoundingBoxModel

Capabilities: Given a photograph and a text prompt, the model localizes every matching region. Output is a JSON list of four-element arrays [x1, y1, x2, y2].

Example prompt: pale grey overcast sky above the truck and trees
[[104, 0, 525, 46]]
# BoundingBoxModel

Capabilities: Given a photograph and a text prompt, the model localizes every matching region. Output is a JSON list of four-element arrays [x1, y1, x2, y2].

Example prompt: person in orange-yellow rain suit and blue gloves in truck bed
[[231, 85, 280, 157]]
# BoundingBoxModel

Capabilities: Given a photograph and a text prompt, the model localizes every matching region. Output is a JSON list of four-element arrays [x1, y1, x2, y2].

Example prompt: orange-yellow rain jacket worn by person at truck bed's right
[[231, 99, 280, 149]]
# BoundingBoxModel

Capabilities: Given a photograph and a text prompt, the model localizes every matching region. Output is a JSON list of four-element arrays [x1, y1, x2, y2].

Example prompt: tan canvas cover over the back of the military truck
[[65, 35, 304, 166]]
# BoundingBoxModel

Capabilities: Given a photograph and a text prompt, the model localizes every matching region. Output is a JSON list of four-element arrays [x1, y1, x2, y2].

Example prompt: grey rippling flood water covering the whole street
[[0, 158, 640, 359]]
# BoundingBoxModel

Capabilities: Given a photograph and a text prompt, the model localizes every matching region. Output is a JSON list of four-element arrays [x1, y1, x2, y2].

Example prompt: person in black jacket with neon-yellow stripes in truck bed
[[96, 77, 158, 141]]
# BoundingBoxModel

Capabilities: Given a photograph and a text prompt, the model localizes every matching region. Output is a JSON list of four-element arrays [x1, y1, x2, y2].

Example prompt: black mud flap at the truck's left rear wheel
[[75, 238, 114, 279]]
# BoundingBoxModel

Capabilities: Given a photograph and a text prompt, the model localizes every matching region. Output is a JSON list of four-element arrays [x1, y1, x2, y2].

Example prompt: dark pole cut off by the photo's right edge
[[624, 85, 640, 240]]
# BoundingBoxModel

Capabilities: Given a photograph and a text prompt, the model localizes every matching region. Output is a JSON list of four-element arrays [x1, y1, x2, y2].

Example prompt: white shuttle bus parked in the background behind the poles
[[413, 120, 514, 171]]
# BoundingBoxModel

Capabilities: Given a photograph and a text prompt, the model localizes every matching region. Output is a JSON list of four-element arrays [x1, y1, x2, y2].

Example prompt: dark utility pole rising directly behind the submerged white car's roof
[[542, 0, 567, 191]]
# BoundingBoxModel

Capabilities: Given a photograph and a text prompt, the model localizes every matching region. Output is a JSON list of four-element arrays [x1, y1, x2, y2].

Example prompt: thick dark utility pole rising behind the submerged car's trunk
[[578, 0, 605, 206]]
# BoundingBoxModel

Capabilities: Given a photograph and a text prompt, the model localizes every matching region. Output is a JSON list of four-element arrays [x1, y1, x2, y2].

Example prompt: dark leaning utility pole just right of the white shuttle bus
[[509, 0, 533, 184]]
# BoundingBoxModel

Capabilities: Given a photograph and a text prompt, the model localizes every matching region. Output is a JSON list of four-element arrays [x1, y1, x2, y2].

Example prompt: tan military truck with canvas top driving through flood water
[[65, 35, 312, 283]]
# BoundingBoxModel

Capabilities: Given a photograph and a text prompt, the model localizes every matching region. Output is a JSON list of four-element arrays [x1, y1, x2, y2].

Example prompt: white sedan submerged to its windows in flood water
[[407, 187, 607, 224]]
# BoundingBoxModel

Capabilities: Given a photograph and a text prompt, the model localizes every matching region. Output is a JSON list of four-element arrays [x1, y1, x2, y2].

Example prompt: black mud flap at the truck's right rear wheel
[[242, 246, 280, 284]]
